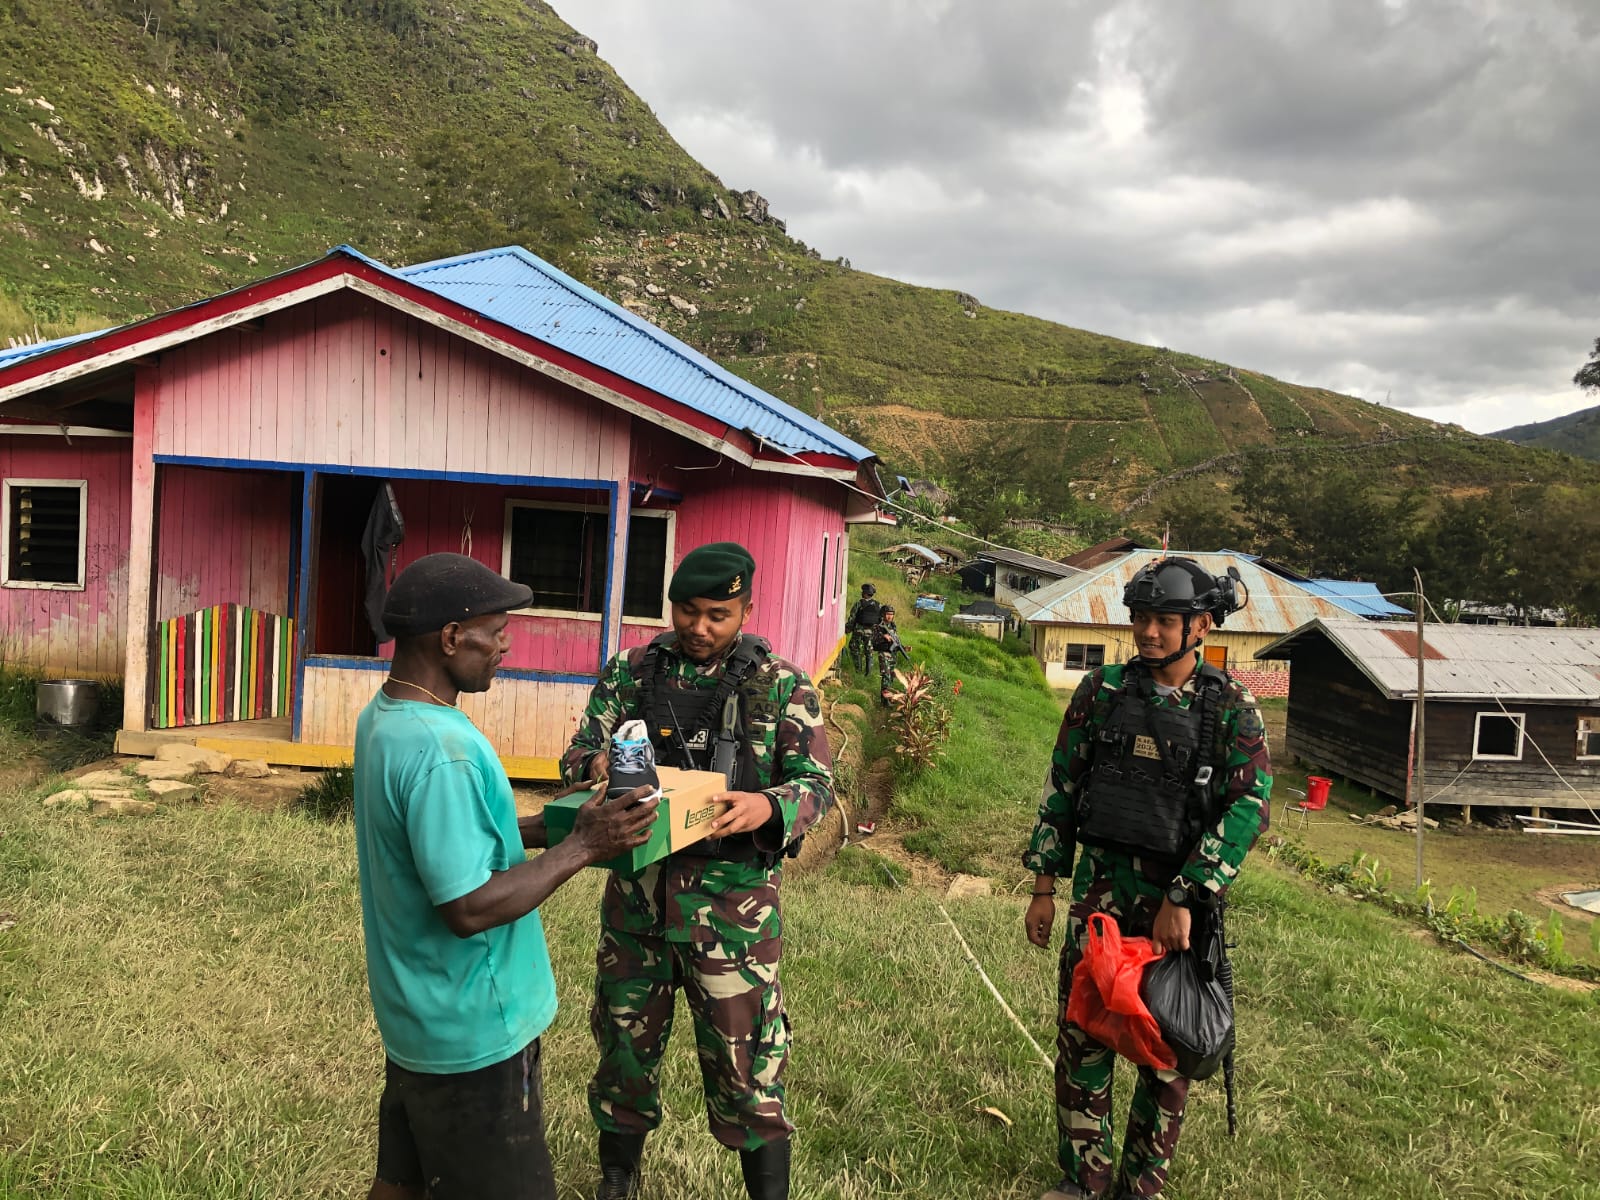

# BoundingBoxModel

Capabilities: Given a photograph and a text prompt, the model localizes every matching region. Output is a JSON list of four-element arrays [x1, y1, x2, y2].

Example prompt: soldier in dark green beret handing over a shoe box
[[562, 542, 834, 1200]]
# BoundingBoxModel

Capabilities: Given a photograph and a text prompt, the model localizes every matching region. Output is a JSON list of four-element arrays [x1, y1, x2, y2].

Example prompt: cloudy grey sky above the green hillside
[[557, 0, 1600, 432]]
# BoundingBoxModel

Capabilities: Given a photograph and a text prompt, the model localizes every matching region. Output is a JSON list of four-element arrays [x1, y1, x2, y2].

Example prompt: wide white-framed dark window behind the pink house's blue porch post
[[501, 501, 674, 624]]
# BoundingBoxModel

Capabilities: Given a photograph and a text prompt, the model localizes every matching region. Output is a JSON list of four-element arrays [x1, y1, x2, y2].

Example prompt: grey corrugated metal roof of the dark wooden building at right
[[1256, 616, 1600, 704]]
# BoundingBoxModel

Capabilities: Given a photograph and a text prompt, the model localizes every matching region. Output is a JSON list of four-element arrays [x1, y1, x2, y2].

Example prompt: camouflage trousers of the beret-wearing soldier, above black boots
[[589, 926, 794, 1150]]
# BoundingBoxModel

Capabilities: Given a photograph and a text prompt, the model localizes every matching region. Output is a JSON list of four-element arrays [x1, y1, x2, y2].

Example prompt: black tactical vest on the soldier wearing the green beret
[[638, 632, 774, 862]]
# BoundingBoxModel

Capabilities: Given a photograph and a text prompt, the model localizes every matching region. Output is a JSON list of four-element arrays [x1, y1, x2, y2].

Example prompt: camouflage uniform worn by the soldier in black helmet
[[1022, 654, 1272, 1195]]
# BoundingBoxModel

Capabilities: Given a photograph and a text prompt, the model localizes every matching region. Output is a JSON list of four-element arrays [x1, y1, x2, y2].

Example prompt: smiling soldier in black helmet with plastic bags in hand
[[1022, 557, 1272, 1200]]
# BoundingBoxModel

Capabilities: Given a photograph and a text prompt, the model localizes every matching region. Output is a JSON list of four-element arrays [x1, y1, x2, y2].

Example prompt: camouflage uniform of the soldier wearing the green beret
[[562, 646, 834, 1150]]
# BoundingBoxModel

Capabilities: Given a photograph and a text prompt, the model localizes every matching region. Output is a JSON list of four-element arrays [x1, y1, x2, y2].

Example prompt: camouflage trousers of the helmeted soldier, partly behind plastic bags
[[1056, 853, 1189, 1195]]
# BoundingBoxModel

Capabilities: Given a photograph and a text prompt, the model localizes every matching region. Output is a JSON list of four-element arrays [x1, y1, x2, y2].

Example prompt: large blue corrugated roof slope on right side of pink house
[[382, 246, 872, 462]]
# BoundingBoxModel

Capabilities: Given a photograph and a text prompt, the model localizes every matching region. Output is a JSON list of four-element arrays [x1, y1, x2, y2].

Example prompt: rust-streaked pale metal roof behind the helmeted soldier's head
[[1016, 550, 1346, 634]]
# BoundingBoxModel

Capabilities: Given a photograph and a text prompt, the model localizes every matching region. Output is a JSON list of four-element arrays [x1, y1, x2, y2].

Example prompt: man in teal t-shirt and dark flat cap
[[355, 554, 654, 1200]]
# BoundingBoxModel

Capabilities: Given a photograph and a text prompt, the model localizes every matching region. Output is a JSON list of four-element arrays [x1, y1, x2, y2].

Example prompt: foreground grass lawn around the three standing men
[[0, 764, 1600, 1200]]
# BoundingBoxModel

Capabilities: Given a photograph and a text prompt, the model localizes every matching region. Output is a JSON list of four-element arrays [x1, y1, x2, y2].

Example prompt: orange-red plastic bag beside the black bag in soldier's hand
[[1067, 912, 1178, 1070]]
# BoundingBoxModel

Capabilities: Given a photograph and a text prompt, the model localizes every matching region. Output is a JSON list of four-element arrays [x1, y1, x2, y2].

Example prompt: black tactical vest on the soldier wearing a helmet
[[1077, 662, 1227, 864]]
